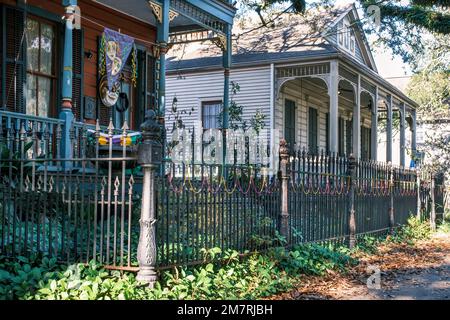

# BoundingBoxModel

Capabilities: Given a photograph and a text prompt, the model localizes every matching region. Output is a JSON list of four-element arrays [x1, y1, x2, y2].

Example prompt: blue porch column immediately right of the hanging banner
[[157, 0, 170, 120]]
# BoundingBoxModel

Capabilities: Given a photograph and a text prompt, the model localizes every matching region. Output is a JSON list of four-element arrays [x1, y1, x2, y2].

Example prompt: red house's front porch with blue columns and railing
[[0, 0, 235, 160]]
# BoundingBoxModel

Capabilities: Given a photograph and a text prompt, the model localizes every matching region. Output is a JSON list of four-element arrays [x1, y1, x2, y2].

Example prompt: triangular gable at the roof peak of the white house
[[325, 6, 377, 72]]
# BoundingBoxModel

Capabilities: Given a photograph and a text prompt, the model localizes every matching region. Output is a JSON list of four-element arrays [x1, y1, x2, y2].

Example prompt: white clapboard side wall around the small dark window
[[166, 66, 270, 138]]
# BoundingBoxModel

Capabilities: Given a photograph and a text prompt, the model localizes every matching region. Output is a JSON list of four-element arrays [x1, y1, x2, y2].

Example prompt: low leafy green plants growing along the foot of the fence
[[0, 245, 356, 300]]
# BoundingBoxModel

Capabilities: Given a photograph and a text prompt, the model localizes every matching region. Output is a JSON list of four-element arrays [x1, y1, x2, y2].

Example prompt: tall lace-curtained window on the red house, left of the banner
[[26, 18, 56, 117]]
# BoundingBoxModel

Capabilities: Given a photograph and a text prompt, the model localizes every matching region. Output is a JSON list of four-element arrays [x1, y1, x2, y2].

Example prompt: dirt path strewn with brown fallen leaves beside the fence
[[270, 233, 450, 300]]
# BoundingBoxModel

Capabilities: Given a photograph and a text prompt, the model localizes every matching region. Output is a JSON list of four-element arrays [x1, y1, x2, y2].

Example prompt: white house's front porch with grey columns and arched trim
[[273, 59, 416, 167]]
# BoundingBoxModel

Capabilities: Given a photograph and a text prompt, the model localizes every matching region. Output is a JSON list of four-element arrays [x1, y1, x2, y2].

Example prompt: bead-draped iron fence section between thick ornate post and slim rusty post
[[156, 161, 280, 267]]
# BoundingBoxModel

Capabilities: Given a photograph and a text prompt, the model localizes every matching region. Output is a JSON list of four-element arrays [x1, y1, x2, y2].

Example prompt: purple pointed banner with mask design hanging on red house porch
[[104, 28, 134, 90]]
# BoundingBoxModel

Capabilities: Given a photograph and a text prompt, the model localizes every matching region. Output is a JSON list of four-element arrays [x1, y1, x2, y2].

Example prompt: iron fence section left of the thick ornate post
[[0, 121, 141, 268]]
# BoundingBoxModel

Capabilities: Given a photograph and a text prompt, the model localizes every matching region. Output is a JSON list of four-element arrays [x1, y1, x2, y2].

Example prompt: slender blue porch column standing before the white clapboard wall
[[222, 24, 233, 163]]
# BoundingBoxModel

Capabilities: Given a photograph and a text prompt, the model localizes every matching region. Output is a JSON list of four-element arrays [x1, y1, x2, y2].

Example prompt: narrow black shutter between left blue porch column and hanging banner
[[72, 29, 84, 122]]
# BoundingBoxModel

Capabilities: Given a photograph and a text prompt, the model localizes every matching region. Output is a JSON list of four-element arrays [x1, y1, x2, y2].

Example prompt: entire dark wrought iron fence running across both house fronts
[[0, 117, 443, 270]]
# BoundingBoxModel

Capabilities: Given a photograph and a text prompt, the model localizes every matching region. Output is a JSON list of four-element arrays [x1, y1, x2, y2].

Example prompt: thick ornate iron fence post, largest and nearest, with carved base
[[137, 110, 162, 287]]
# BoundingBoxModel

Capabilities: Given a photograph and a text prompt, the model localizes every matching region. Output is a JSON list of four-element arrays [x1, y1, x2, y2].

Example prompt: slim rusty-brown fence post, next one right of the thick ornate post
[[280, 139, 290, 243]]
